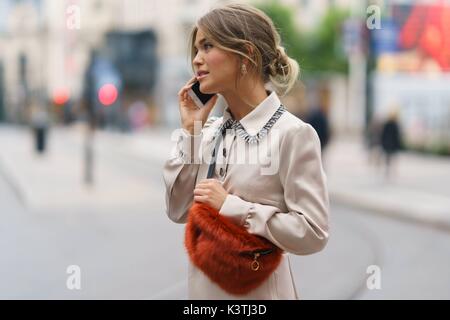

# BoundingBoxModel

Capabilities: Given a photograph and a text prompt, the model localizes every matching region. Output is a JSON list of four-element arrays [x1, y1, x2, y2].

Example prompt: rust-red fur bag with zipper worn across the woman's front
[[185, 202, 282, 295]]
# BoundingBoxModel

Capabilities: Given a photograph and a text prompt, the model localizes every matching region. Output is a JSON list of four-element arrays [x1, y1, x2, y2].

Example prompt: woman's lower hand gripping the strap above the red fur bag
[[194, 179, 228, 211]]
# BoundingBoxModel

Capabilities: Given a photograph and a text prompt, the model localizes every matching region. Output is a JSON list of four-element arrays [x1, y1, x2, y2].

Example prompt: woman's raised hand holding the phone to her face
[[178, 77, 218, 135]]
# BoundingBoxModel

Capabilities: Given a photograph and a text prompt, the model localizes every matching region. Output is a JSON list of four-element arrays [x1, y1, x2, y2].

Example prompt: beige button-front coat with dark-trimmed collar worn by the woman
[[164, 92, 329, 299]]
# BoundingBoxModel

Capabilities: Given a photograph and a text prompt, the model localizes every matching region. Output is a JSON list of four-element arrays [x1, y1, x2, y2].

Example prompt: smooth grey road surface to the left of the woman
[[0, 160, 186, 299]]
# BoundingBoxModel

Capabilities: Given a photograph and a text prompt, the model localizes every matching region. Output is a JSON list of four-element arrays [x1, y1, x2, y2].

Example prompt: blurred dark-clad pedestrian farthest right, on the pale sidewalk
[[380, 109, 402, 178]]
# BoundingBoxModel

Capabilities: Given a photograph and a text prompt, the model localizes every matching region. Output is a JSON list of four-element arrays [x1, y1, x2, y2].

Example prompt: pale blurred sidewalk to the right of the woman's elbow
[[324, 134, 450, 230]]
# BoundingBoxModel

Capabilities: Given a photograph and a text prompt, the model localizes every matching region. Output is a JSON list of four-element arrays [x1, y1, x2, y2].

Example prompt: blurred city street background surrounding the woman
[[0, 0, 450, 299]]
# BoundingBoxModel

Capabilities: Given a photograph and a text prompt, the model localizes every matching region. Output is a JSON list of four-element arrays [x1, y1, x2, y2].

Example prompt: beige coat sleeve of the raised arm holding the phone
[[163, 117, 217, 223]]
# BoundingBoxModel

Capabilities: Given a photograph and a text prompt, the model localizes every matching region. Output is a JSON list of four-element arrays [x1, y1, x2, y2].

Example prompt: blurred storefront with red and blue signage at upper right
[[371, 0, 450, 154]]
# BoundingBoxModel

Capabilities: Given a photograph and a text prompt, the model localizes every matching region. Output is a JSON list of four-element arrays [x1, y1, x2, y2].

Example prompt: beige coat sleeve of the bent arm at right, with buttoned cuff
[[220, 124, 329, 255]]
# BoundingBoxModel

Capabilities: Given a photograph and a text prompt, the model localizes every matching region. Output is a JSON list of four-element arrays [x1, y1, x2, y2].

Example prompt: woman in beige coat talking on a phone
[[164, 5, 328, 299]]
